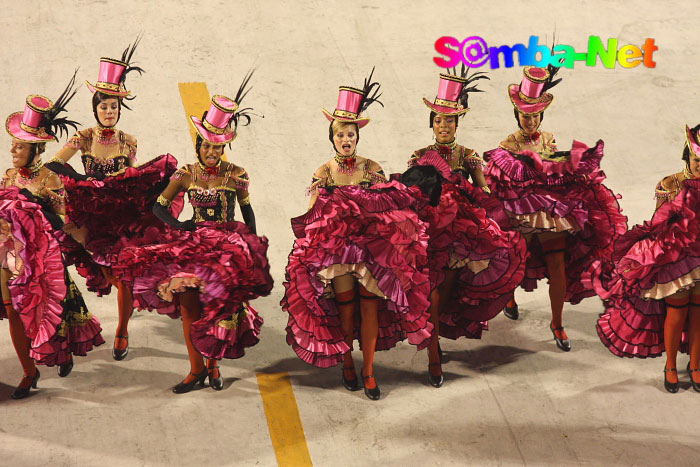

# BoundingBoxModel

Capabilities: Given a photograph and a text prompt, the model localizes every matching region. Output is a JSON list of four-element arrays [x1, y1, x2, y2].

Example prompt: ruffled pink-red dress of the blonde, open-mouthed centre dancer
[[281, 161, 433, 368]]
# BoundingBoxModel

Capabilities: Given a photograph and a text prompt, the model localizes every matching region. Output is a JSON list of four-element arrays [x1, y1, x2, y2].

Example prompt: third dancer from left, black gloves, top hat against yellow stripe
[[115, 71, 273, 394]]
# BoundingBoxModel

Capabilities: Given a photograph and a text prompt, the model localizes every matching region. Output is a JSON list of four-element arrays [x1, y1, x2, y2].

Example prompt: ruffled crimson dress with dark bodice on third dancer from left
[[113, 165, 273, 360]]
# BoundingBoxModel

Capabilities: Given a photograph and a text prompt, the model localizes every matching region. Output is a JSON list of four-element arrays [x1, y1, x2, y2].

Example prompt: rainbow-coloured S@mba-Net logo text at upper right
[[433, 36, 659, 69]]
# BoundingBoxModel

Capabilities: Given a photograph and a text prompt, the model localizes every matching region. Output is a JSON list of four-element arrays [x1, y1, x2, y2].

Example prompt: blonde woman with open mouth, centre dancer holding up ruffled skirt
[[282, 69, 432, 400]]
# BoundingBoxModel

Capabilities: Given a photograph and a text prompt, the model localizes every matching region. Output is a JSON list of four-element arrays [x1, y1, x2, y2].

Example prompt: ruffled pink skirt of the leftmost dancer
[[0, 187, 104, 366]]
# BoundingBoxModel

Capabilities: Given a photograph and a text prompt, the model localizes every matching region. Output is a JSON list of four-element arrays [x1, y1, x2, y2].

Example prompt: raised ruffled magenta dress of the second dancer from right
[[484, 141, 627, 304]]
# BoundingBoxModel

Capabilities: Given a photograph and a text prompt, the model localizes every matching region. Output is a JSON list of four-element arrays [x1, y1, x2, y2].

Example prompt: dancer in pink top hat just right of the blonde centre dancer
[[402, 66, 526, 388]]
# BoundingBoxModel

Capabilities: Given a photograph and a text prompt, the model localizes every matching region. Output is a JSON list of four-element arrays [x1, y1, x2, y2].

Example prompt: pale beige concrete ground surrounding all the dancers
[[0, 0, 700, 466]]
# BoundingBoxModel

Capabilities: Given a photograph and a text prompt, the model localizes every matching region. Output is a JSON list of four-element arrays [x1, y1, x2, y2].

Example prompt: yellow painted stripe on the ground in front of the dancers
[[257, 373, 313, 466]]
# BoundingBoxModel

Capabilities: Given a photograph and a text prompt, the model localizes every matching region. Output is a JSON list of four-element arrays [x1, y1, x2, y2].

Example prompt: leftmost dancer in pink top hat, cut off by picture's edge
[[0, 75, 104, 399]]
